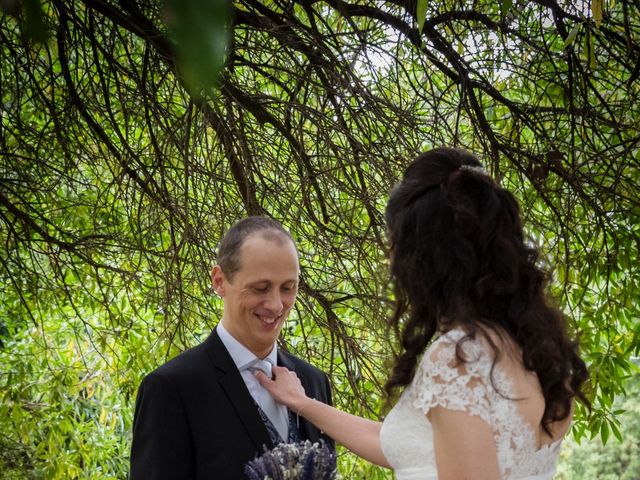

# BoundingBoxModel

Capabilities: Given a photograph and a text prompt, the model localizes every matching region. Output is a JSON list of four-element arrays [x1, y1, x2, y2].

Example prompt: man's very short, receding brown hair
[[217, 216, 297, 280]]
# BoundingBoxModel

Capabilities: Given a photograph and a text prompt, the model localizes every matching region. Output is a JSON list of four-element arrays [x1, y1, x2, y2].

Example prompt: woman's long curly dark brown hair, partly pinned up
[[385, 148, 589, 434]]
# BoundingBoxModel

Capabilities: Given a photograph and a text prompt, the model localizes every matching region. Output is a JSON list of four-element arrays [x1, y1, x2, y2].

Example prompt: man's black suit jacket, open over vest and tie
[[131, 330, 333, 480]]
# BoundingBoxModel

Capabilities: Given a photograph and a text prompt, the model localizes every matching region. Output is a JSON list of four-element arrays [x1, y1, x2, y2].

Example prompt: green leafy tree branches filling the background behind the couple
[[0, 0, 640, 478]]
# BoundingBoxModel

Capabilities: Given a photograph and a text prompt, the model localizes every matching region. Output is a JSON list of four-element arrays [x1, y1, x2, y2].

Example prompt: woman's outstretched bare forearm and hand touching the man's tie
[[256, 366, 391, 468]]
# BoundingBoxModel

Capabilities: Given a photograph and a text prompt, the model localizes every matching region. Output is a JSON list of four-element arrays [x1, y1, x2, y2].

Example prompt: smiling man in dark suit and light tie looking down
[[131, 217, 333, 480]]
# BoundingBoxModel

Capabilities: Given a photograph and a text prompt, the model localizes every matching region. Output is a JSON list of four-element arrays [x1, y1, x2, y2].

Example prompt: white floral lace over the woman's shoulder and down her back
[[407, 330, 558, 478]]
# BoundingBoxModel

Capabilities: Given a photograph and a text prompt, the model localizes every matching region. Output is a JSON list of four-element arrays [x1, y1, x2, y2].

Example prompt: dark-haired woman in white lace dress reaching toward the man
[[259, 148, 588, 480]]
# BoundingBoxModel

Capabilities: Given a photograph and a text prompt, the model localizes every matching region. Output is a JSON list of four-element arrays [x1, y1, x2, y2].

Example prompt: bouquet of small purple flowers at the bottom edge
[[244, 440, 339, 480]]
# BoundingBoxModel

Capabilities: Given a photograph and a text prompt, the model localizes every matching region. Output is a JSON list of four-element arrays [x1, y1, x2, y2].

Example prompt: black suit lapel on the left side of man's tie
[[205, 329, 272, 453]]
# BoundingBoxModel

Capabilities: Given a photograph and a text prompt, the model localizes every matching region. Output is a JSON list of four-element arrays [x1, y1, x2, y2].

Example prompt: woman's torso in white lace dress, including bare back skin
[[381, 328, 571, 480]]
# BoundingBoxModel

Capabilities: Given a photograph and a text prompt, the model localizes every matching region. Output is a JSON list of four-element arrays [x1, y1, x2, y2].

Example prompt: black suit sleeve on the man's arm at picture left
[[130, 373, 195, 480]]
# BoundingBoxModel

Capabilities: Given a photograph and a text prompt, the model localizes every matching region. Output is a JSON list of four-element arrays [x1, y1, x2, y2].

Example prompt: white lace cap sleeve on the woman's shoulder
[[411, 331, 492, 424]]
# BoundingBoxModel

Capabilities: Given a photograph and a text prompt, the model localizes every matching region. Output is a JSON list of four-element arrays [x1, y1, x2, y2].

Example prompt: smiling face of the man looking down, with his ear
[[211, 232, 300, 358]]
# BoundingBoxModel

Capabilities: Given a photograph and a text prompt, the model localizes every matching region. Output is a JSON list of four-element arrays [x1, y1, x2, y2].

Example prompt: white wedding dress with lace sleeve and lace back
[[380, 330, 561, 480]]
